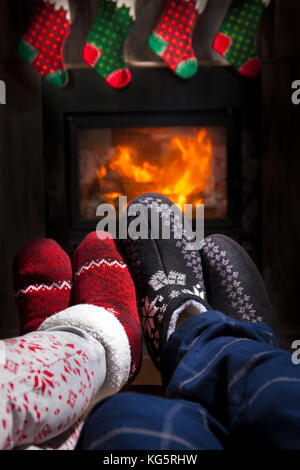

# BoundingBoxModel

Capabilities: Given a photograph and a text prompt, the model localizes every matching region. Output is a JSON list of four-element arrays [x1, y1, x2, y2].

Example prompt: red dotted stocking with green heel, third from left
[[148, 0, 197, 78]]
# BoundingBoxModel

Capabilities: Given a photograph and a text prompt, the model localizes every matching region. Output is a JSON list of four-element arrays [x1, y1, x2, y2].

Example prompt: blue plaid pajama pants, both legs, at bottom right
[[76, 311, 300, 450]]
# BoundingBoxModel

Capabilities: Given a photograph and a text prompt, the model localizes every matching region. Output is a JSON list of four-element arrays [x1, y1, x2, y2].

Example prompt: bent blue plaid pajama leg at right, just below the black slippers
[[163, 312, 300, 449]]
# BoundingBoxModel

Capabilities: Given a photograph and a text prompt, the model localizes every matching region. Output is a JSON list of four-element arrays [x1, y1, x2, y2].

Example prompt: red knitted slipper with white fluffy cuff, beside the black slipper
[[40, 232, 142, 398]]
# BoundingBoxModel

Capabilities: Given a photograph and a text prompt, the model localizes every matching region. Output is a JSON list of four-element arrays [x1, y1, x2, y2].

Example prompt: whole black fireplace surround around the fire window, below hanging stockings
[[43, 66, 259, 251]]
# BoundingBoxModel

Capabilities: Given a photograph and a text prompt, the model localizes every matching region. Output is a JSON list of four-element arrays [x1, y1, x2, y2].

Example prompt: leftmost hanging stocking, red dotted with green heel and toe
[[18, 0, 71, 87]]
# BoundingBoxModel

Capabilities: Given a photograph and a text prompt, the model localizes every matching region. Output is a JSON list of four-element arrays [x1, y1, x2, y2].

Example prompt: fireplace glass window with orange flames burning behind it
[[76, 126, 228, 222]]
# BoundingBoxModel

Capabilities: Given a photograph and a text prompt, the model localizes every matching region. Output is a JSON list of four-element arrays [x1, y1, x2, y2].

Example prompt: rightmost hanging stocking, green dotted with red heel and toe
[[213, 0, 270, 77]]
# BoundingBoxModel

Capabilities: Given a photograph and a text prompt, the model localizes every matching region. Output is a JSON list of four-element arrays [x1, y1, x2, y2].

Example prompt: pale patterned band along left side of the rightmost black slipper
[[202, 238, 263, 323]]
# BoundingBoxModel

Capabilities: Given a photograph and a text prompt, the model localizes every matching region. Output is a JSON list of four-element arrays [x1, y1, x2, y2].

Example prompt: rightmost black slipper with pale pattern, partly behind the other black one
[[200, 234, 281, 346]]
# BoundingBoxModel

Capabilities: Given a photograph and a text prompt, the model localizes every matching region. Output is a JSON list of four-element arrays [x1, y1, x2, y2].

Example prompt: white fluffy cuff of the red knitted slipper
[[39, 304, 131, 398]]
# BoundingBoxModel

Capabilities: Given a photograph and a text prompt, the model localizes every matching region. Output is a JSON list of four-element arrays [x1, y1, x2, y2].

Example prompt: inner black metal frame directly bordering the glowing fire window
[[65, 111, 240, 233]]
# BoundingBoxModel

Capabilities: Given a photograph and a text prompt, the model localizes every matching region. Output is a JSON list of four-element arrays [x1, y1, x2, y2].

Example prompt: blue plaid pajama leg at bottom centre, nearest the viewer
[[76, 393, 226, 450]]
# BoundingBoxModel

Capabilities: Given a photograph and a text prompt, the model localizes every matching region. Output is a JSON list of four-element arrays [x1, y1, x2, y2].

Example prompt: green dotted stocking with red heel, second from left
[[83, 0, 136, 88]]
